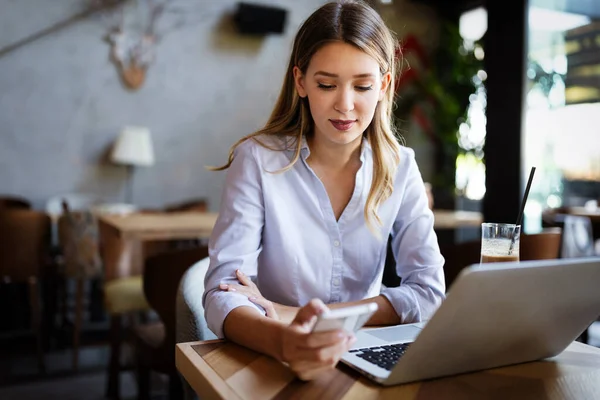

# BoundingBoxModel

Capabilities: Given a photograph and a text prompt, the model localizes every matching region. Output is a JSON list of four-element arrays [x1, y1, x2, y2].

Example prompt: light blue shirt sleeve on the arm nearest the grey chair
[[202, 139, 264, 338]]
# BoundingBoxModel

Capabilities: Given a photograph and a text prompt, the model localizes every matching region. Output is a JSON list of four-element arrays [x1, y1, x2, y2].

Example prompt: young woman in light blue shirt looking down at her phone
[[203, 1, 445, 379]]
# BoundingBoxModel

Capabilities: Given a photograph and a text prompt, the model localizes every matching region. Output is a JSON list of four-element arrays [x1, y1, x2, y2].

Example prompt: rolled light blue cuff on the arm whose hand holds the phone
[[204, 290, 266, 339]]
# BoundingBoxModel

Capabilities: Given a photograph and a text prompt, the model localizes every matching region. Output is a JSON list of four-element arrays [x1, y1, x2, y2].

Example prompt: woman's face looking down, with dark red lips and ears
[[294, 42, 391, 145]]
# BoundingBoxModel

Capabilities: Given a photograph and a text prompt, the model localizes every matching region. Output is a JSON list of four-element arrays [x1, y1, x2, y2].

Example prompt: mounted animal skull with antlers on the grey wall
[[108, 0, 165, 90]]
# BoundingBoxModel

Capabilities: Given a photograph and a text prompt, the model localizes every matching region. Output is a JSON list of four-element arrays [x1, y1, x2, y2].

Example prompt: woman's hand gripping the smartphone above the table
[[281, 299, 356, 380]]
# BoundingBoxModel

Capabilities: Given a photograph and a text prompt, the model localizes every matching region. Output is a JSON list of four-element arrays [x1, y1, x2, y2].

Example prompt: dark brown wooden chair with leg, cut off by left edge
[[0, 210, 50, 373]]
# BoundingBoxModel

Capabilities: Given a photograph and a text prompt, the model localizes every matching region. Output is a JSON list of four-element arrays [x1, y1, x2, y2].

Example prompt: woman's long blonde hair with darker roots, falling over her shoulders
[[213, 0, 400, 230]]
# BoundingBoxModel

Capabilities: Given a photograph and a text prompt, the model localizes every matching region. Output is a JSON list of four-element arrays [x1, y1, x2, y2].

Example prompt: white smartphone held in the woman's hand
[[312, 303, 377, 333]]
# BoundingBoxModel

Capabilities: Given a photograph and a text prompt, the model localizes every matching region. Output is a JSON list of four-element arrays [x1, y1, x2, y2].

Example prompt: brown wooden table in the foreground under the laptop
[[176, 340, 600, 400]]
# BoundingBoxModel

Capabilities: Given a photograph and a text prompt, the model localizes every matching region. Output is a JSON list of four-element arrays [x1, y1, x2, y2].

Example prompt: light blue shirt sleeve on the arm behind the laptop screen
[[381, 150, 446, 323]]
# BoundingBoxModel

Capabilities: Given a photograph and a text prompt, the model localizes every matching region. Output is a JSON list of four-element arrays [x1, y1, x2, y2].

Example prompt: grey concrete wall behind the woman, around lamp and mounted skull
[[0, 0, 436, 210]]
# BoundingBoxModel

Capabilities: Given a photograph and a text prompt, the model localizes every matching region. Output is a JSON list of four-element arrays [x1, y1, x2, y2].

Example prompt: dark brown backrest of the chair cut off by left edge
[[0, 210, 50, 282]]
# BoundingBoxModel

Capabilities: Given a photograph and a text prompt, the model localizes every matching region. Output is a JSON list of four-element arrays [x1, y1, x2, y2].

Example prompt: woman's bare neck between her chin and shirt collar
[[306, 135, 362, 169]]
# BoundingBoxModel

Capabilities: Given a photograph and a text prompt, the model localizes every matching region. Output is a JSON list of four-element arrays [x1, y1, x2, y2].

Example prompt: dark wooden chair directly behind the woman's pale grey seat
[[134, 246, 208, 399]]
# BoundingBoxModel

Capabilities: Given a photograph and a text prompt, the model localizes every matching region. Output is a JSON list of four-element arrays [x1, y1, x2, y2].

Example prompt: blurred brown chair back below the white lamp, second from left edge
[[58, 209, 102, 278]]
